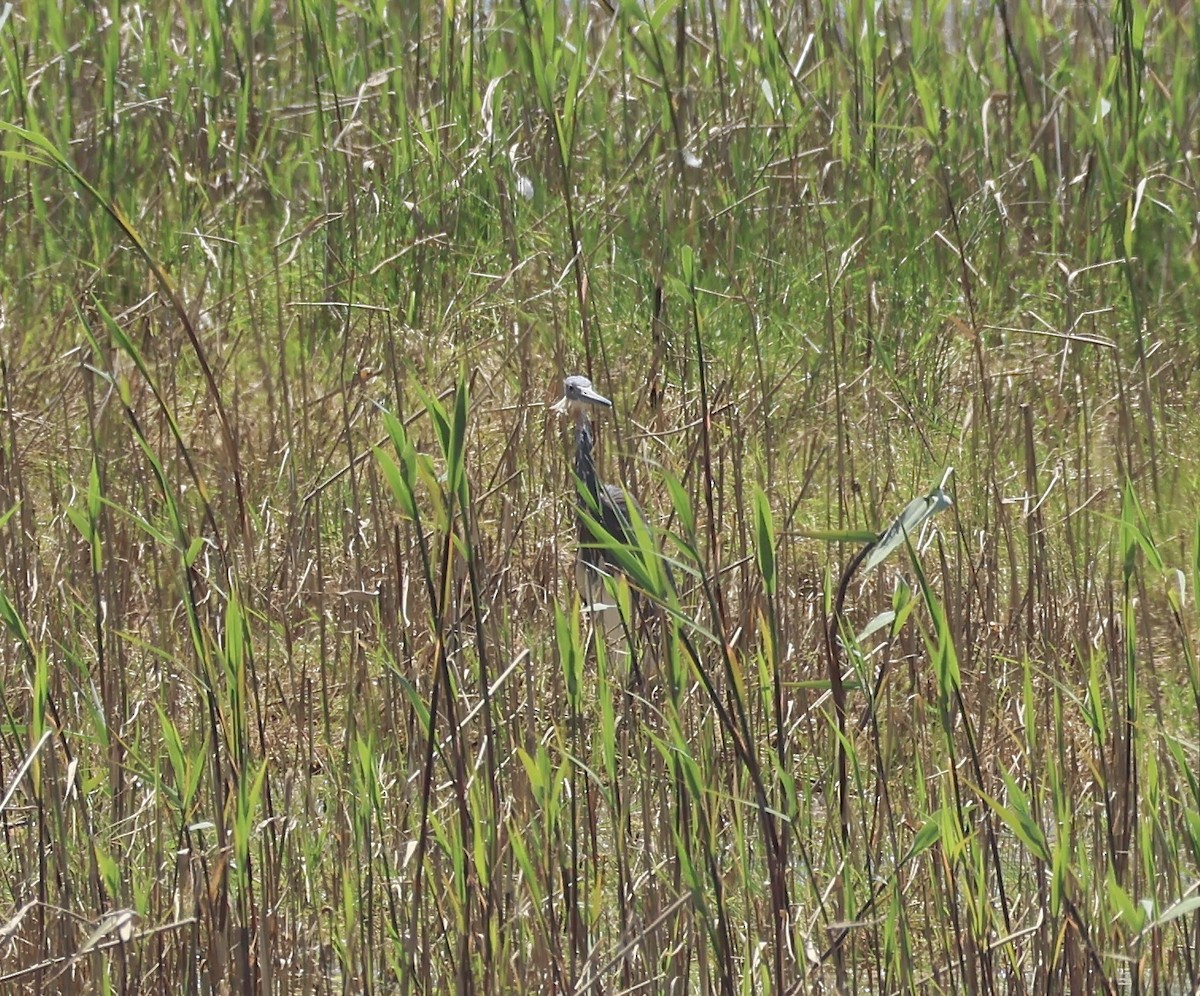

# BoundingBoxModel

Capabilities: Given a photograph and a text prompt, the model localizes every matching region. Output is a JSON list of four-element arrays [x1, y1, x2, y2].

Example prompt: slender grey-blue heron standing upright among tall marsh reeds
[[552, 374, 641, 601]]
